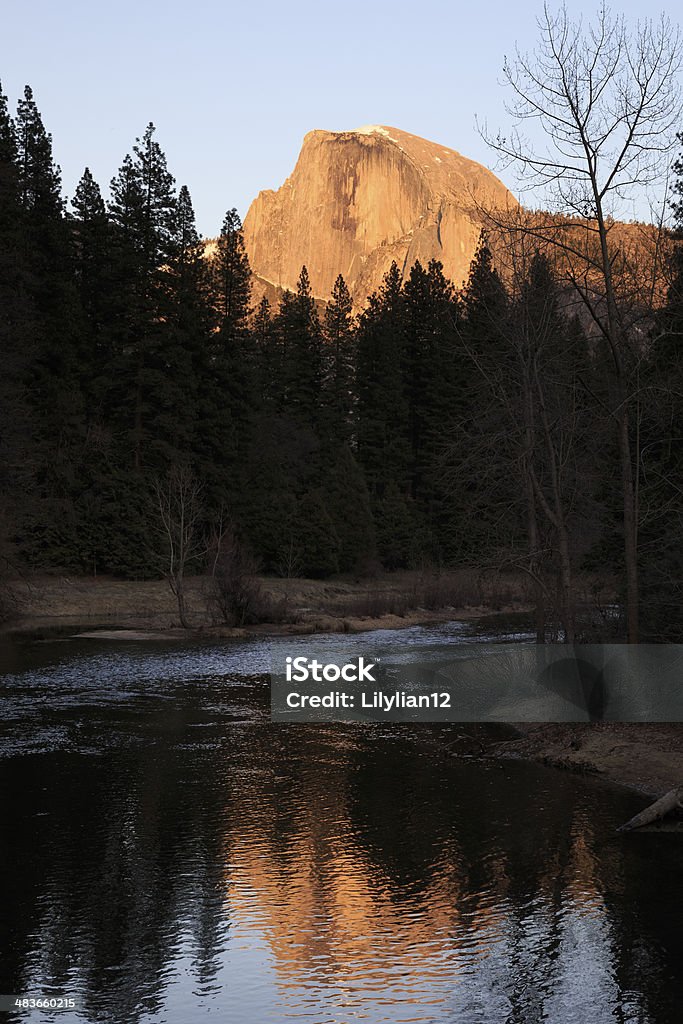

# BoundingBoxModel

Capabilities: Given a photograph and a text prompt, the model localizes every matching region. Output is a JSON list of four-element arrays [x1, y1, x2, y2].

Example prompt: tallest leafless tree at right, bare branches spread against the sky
[[483, 6, 681, 642]]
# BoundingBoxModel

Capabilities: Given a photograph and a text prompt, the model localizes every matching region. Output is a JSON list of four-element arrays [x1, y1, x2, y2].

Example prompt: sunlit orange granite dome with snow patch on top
[[244, 125, 517, 305]]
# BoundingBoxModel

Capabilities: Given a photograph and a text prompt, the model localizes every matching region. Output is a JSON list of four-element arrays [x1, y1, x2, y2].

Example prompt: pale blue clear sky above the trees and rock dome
[[0, 0, 677, 237]]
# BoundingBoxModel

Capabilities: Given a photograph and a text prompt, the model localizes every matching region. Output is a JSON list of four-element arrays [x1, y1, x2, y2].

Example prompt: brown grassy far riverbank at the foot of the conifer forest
[[4, 569, 528, 639]]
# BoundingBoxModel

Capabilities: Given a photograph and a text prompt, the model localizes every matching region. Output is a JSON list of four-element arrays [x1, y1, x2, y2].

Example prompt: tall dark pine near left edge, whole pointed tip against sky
[[15, 86, 86, 568]]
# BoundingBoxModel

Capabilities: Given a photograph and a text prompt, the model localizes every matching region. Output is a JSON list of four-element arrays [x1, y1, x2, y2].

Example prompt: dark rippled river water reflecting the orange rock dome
[[0, 627, 683, 1024]]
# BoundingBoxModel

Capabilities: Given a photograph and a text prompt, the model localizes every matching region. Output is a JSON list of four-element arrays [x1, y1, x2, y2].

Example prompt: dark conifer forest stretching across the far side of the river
[[0, 81, 683, 641]]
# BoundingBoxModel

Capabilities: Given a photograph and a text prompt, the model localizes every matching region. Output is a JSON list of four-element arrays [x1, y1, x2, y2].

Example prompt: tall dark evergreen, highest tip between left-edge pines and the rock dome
[[83, 124, 187, 575]]
